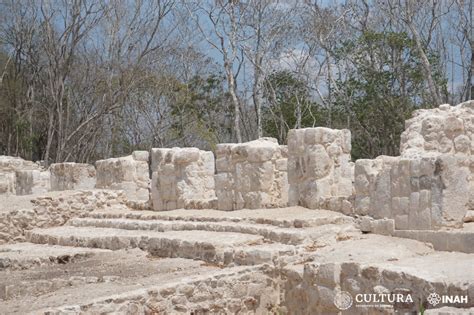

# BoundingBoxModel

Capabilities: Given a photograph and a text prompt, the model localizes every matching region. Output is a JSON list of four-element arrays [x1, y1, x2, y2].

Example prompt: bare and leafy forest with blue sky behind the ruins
[[0, 0, 474, 164]]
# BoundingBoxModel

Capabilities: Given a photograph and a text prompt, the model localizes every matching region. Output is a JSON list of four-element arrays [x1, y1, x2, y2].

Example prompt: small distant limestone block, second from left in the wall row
[[49, 163, 96, 191]]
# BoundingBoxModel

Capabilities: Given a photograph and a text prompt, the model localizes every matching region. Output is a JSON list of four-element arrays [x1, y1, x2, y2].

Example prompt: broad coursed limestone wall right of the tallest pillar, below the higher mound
[[355, 155, 474, 230]]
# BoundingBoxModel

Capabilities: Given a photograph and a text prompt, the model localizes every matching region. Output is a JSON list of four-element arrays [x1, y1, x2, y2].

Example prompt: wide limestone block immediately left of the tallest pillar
[[215, 138, 288, 210]]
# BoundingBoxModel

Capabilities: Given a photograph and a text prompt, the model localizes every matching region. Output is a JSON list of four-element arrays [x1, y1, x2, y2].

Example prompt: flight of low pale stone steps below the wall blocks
[[26, 210, 360, 266]]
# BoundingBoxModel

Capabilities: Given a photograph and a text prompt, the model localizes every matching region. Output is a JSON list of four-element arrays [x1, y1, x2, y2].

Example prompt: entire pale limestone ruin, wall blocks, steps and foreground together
[[0, 101, 474, 314]]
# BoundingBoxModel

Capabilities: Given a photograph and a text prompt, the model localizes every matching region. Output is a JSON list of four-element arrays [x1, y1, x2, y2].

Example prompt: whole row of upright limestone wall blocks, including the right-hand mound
[[0, 101, 474, 230]]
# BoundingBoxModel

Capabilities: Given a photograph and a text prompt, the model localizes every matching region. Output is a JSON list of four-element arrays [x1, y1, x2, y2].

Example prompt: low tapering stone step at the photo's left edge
[[0, 243, 110, 271]]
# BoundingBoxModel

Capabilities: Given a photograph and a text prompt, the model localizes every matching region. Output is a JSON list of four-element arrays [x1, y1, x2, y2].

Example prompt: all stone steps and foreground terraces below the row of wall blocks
[[0, 207, 474, 314]]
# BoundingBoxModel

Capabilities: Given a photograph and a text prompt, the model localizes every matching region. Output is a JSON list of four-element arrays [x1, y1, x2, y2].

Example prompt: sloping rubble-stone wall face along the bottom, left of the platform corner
[[36, 267, 279, 314]]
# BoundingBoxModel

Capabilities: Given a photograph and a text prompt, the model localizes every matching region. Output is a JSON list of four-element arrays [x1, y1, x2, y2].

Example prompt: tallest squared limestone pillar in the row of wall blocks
[[288, 127, 353, 213]]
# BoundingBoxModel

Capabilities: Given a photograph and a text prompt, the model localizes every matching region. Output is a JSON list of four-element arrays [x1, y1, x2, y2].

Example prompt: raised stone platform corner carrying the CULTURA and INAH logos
[[281, 251, 474, 315]]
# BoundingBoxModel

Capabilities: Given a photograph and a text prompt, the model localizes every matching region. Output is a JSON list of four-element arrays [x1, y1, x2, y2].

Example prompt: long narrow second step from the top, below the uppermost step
[[68, 218, 311, 245]]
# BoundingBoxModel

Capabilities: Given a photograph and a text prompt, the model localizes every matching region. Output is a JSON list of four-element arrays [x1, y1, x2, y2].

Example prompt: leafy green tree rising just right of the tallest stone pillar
[[336, 32, 446, 158]]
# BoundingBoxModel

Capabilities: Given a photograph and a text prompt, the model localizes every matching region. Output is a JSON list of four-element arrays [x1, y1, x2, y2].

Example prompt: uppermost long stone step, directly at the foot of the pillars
[[81, 207, 354, 228]]
